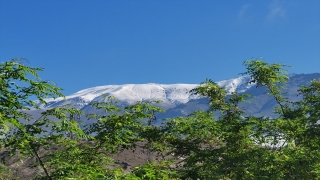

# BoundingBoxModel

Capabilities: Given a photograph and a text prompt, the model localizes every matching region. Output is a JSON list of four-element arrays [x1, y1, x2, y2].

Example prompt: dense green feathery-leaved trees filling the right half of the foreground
[[148, 60, 320, 179]]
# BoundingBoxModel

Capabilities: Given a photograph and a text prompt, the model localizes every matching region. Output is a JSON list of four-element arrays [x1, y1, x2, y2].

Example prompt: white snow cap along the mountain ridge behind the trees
[[42, 76, 253, 109]]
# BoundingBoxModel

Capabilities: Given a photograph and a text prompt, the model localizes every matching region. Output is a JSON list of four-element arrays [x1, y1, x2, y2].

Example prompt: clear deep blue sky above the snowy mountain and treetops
[[0, 0, 320, 95]]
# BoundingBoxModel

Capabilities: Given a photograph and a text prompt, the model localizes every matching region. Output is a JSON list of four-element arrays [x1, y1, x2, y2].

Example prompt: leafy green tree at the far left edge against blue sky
[[0, 59, 84, 179]]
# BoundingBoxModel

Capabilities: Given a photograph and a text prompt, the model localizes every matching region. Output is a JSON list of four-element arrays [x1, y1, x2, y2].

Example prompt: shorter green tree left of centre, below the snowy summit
[[46, 96, 162, 179]]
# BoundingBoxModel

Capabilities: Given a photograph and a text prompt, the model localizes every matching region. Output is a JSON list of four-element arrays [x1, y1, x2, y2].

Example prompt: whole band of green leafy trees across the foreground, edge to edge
[[0, 59, 320, 180]]
